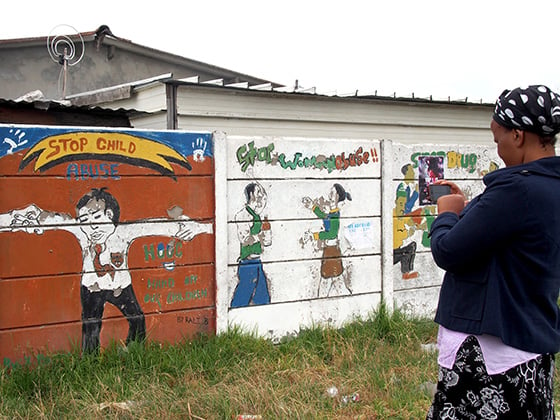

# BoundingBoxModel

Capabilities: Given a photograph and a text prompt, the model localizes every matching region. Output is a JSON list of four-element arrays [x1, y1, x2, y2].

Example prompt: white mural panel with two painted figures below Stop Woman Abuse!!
[[225, 137, 382, 335]]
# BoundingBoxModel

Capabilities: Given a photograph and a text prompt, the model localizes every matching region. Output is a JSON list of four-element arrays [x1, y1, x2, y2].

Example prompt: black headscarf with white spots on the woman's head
[[493, 85, 560, 137]]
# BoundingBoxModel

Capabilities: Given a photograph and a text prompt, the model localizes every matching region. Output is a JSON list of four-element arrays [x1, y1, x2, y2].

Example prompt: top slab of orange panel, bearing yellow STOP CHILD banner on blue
[[0, 130, 214, 181]]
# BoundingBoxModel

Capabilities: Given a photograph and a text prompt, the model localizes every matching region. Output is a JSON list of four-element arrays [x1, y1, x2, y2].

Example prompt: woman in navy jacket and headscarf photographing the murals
[[427, 86, 560, 419]]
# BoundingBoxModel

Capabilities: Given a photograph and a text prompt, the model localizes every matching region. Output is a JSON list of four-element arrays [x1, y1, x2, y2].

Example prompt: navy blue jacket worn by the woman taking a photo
[[430, 157, 560, 354]]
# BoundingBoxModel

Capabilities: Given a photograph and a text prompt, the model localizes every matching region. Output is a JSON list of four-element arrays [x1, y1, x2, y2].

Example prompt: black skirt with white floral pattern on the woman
[[426, 336, 555, 420]]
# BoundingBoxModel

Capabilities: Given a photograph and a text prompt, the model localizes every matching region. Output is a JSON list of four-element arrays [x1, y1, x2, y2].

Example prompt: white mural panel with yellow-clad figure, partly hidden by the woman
[[392, 144, 501, 299]]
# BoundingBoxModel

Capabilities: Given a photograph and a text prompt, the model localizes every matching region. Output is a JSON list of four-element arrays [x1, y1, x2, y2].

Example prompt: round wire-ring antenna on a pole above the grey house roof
[[47, 25, 85, 99]]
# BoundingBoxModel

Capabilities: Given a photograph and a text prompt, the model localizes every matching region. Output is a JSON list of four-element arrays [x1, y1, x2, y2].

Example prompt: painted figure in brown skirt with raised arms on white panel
[[302, 184, 352, 297]]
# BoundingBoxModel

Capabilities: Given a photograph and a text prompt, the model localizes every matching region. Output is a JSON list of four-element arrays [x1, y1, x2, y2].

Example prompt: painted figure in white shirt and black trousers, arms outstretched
[[0, 188, 213, 353]]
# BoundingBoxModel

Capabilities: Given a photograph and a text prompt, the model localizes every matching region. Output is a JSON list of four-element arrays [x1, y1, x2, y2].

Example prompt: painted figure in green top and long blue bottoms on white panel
[[231, 182, 272, 308]]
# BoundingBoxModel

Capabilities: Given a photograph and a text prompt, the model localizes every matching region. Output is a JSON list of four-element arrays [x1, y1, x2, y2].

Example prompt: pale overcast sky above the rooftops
[[0, 0, 560, 102]]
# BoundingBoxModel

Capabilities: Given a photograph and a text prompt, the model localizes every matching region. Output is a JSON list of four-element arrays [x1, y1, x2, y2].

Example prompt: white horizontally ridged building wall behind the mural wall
[[117, 83, 493, 145]]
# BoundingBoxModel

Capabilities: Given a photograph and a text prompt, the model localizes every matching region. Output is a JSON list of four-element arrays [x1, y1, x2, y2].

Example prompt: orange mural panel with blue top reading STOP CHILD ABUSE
[[0, 125, 215, 359]]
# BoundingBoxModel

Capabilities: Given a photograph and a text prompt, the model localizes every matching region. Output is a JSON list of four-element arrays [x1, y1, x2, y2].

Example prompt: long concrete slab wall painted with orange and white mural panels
[[0, 121, 500, 360]]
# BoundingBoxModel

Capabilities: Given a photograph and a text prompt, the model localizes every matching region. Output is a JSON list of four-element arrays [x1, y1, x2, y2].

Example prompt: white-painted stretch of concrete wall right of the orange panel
[[215, 135, 500, 339]]
